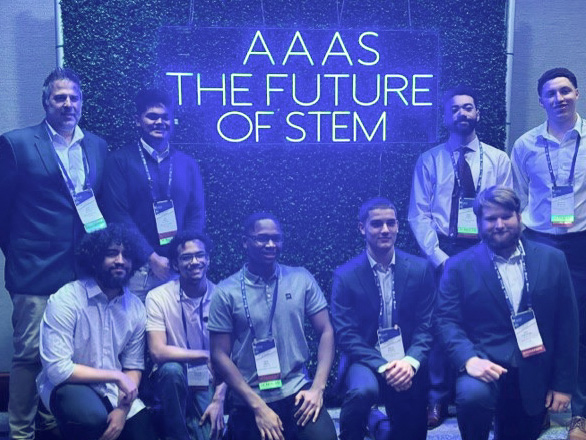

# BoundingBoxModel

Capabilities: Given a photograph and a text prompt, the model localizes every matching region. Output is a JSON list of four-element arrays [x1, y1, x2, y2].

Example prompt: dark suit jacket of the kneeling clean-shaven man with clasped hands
[[331, 249, 435, 380]]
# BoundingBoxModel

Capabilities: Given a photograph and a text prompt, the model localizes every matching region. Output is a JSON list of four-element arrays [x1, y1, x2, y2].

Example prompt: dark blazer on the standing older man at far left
[[0, 122, 107, 295]]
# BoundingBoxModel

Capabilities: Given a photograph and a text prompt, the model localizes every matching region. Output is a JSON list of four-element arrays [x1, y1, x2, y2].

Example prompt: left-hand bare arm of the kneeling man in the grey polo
[[210, 332, 285, 440]]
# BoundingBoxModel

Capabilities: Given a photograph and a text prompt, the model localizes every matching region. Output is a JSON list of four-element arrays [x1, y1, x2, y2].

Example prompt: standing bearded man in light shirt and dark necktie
[[408, 86, 513, 428]]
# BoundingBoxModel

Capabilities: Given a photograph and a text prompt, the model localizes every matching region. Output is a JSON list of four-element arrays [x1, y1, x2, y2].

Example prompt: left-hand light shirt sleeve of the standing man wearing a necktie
[[408, 156, 448, 267]]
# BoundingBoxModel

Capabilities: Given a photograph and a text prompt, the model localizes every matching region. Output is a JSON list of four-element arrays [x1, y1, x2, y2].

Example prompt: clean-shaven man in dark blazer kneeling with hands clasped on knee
[[332, 197, 434, 440]]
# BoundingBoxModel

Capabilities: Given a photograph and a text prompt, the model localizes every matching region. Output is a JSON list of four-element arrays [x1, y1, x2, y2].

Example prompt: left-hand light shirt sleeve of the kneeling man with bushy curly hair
[[39, 285, 77, 386]]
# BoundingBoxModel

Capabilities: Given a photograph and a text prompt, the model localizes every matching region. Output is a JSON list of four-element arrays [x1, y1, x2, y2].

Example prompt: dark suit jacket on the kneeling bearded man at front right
[[436, 240, 578, 414]]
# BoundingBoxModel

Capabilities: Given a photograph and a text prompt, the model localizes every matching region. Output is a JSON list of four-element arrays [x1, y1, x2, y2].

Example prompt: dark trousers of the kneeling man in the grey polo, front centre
[[226, 384, 337, 440]]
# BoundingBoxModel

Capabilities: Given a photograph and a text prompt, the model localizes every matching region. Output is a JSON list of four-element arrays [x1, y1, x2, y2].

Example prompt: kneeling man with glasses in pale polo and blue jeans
[[145, 231, 226, 440]]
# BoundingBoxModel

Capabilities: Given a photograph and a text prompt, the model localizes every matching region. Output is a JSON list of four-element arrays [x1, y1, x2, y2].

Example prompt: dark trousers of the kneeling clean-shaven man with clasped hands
[[340, 363, 427, 440]]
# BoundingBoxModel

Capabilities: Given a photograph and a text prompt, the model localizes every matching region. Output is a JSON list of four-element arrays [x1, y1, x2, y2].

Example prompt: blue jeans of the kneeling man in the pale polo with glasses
[[153, 362, 212, 440]]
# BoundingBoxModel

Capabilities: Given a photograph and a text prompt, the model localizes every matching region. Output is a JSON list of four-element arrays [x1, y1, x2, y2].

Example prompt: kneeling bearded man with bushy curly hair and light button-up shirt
[[37, 225, 155, 440]]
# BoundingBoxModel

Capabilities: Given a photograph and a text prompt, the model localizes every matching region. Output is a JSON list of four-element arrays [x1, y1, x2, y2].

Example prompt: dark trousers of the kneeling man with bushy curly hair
[[50, 383, 156, 440]]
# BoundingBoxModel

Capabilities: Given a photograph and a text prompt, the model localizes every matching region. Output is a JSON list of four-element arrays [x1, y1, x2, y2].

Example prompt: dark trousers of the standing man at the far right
[[523, 229, 586, 417]]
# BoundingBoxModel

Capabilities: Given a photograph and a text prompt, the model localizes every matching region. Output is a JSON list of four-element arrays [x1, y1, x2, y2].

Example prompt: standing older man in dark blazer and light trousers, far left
[[0, 68, 107, 439]]
